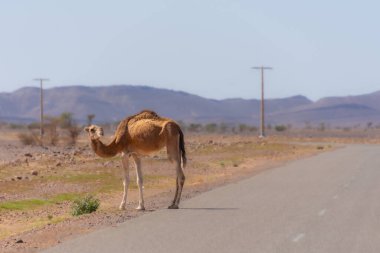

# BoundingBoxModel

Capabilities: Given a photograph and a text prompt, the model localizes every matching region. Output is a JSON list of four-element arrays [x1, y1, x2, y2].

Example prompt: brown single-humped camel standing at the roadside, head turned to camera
[[84, 110, 186, 210]]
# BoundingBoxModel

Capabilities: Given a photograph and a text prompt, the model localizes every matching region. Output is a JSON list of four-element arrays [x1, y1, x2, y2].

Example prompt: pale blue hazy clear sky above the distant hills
[[0, 0, 380, 99]]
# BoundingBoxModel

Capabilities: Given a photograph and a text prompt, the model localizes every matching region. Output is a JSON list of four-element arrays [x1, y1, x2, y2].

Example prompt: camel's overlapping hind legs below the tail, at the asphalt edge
[[167, 136, 185, 209]]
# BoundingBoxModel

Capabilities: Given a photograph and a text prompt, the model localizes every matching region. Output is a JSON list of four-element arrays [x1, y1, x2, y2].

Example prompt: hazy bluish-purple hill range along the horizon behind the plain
[[0, 85, 380, 126]]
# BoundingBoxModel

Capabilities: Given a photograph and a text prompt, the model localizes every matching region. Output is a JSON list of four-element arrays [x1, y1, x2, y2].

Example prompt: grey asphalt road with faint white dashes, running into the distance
[[41, 145, 380, 253]]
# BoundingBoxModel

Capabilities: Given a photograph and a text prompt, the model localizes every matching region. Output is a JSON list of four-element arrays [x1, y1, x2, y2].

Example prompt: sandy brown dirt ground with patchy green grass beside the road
[[0, 129, 337, 252]]
